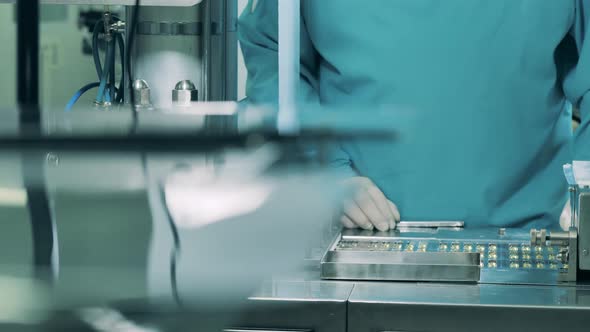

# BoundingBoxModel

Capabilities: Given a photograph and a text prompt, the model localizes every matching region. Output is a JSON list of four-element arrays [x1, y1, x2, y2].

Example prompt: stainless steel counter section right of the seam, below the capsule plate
[[348, 283, 590, 332]]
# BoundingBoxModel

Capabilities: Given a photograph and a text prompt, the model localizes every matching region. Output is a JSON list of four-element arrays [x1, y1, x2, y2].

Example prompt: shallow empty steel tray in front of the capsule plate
[[321, 251, 480, 282]]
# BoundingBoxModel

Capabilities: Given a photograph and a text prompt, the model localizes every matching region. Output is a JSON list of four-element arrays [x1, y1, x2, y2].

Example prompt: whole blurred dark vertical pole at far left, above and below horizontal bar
[[16, 0, 57, 281]]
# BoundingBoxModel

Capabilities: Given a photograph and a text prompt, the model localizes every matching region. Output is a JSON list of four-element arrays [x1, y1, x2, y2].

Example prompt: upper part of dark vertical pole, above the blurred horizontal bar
[[16, 0, 41, 130]]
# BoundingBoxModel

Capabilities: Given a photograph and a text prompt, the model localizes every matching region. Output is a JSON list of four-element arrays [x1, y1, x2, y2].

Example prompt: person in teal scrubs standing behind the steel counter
[[239, 0, 590, 230]]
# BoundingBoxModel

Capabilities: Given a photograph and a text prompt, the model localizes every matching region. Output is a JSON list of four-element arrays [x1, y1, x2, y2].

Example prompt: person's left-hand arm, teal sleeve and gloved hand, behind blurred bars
[[239, 0, 399, 231]]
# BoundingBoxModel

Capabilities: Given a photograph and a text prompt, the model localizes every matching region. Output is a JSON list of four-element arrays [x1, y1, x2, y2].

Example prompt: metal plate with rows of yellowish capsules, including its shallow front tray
[[322, 228, 569, 285]]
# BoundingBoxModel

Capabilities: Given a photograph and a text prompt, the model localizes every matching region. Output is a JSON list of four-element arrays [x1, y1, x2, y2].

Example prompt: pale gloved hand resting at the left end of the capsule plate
[[340, 176, 400, 232]]
